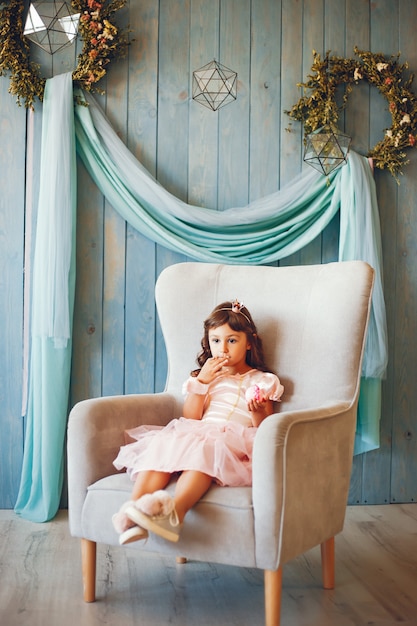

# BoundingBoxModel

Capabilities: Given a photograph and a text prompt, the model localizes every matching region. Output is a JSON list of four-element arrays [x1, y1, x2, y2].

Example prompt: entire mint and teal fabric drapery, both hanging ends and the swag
[[16, 74, 387, 522]]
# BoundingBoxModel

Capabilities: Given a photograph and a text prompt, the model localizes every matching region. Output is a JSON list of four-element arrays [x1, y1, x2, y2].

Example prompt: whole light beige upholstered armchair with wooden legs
[[68, 261, 373, 626]]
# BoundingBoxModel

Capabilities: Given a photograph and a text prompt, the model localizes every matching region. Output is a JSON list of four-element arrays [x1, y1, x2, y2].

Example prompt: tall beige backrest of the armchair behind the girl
[[156, 261, 373, 411]]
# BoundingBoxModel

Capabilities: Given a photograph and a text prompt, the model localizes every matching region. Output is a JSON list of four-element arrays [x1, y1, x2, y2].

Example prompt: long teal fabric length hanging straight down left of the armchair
[[15, 74, 76, 522]]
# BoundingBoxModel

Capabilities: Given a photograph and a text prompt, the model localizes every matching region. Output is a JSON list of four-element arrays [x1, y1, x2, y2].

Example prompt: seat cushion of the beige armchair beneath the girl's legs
[[82, 473, 255, 567]]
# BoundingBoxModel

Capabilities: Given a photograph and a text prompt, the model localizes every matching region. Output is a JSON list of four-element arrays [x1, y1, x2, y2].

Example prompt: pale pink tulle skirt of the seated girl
[[114, 417, 256, 487]]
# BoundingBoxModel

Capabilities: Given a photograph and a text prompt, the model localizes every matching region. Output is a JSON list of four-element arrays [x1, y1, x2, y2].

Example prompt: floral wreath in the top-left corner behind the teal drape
[[0, 0, 128, 109]]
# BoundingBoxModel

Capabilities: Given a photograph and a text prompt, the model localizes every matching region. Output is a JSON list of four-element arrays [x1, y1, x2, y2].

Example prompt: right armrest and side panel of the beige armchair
[[253, 402, 356, 570]]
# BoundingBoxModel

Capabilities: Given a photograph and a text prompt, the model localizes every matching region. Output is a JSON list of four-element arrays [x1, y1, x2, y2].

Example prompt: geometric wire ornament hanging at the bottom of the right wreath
[[304, 124, 351, 176]]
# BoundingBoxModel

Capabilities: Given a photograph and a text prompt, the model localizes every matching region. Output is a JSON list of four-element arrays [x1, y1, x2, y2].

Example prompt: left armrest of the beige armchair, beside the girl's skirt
[[67, 392, 178, 536]]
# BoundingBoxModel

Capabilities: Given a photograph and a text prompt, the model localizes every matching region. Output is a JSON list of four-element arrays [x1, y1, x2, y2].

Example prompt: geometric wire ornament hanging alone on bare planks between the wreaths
[[193, 60, 237, 111]]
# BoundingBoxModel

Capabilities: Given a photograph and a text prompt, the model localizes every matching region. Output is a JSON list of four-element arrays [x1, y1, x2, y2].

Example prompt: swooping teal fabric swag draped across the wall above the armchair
[[75, 96, 341, 264]]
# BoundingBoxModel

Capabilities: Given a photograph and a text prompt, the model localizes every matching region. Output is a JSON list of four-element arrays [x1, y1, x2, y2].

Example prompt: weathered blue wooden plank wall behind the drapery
[[0, 0, 417, 508]]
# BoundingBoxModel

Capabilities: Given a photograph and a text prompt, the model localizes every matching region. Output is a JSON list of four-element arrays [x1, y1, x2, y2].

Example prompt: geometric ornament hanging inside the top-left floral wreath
[[23, 0, 80, 54]]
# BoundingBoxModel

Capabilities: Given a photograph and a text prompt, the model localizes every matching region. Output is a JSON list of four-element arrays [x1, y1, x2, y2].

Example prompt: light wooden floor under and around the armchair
[[0, 504, 417, 626]]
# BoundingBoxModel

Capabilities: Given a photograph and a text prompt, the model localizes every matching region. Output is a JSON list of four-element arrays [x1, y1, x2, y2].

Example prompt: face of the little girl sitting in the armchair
[[208, 324, 251, 372]]
